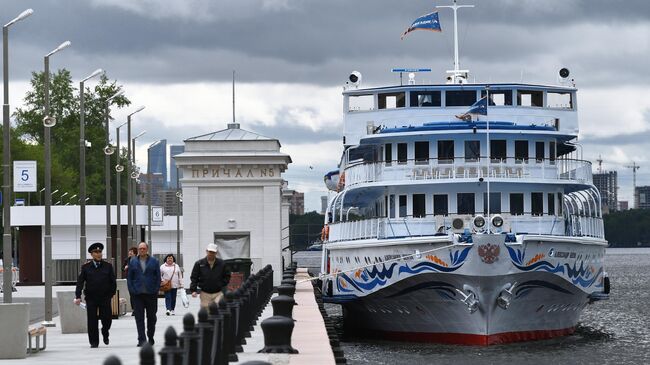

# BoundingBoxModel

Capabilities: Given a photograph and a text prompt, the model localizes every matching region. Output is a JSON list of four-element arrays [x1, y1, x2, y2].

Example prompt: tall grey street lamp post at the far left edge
[[2, 9, 34, 303]]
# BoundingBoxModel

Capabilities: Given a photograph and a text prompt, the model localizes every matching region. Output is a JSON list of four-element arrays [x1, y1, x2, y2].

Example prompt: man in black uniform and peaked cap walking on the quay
[[74, 242, 117, 348]]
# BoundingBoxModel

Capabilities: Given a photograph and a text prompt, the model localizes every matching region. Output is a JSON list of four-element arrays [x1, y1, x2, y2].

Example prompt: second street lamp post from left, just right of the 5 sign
[[43, 41, 70, 327]]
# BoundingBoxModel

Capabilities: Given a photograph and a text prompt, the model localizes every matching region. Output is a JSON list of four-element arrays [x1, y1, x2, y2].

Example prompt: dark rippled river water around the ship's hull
[[294, 248, 650, 365]]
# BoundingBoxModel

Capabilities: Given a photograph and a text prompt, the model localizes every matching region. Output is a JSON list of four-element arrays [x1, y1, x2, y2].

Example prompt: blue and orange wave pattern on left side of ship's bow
[[336, 246, 473, 293]]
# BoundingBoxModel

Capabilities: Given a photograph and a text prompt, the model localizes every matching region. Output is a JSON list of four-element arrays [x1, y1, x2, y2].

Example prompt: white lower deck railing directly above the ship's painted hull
[[328, 213, 604, 242]]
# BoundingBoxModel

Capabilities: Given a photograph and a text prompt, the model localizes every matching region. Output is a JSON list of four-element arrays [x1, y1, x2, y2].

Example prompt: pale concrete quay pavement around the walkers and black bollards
[[0, 269, 335, 365]]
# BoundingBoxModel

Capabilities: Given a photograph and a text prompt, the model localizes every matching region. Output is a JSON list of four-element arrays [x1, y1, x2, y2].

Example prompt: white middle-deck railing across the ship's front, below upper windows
[[345, 158, 592, 186]]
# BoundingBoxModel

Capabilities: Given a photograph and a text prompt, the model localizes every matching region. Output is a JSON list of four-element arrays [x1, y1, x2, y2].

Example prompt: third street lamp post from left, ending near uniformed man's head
[[79, 68, 103, 267]]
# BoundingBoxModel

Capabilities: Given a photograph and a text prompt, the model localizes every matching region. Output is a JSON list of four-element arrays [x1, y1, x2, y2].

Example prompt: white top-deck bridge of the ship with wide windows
[[343, 84, 578, 146]]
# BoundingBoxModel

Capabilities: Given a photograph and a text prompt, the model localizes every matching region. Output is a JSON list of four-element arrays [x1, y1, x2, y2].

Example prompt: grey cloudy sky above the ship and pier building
[[5, 0, 650, 210]]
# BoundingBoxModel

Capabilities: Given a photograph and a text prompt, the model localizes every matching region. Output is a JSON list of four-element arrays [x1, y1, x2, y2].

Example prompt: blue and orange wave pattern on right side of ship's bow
[[506, 246, 603, 288]]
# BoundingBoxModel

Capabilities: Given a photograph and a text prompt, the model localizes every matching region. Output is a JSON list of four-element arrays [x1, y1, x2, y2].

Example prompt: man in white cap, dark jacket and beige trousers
[[190, 243, 230, 307]]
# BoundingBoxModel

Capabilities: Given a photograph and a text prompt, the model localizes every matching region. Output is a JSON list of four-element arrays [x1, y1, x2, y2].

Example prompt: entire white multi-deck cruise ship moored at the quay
[[320, 2, 609, 345]]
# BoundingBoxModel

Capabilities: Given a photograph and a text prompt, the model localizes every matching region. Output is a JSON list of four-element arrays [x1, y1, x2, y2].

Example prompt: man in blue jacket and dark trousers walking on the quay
[[126, 242, 160, 347]]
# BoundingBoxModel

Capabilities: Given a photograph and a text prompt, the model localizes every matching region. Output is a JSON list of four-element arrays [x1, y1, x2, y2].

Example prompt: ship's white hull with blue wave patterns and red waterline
[[324, 234, 605, 345]]
